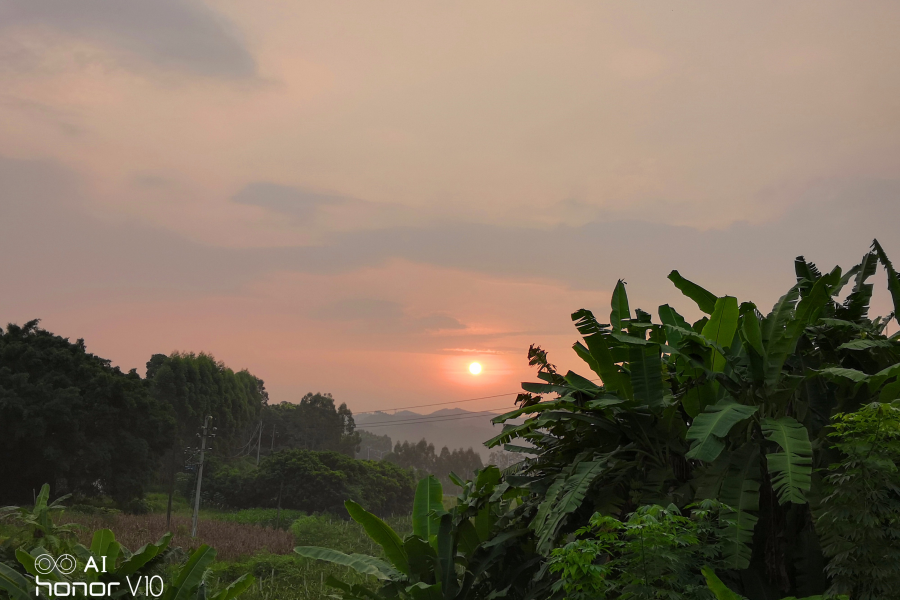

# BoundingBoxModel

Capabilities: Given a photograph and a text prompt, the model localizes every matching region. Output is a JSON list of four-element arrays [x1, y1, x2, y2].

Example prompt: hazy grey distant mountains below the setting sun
[[353, 408, 516, 460]]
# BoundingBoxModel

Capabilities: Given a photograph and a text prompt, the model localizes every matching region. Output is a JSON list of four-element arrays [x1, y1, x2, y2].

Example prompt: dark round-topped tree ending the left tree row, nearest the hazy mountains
[[263, 393, 360, 456]]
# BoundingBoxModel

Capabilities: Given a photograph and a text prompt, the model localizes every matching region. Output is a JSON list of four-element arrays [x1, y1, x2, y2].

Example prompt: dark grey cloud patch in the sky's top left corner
[[0, 0, 256, 78]]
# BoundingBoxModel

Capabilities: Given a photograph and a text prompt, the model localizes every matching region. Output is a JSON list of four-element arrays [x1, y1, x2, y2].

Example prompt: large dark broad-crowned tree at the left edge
[[0, 321, 173, 502]]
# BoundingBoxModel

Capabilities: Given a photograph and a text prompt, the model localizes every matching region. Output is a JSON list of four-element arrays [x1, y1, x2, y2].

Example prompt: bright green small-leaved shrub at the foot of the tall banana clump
[[550, 501, 722, 600]]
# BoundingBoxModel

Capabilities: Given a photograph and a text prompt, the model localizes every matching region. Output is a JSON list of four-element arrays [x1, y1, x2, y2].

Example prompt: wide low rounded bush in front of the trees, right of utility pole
[[193, 449, 415, 515]]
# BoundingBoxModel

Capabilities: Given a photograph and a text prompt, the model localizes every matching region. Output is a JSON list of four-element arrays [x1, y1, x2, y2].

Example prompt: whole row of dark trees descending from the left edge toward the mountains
[[0, 320, 402, 510]]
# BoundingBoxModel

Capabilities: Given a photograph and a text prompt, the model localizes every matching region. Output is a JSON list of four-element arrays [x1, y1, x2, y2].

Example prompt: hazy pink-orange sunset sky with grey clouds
[[0, 0, 900, 412]]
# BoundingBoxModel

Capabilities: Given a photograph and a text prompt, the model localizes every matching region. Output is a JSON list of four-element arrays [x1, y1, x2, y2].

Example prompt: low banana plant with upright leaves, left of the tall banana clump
[[294, 467, 526, 600]]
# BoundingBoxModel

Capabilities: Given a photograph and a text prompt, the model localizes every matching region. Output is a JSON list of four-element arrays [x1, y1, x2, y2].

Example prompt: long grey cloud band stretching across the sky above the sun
[[0, 158, 900, 324]]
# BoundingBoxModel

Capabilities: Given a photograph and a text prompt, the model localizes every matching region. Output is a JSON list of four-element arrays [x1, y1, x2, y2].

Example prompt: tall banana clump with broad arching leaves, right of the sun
[[486, 240, 900, 598]]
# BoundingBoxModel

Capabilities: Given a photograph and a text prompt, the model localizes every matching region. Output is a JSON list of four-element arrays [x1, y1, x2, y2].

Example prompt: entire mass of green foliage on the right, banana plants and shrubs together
[[297, 242, 900, 600]]
